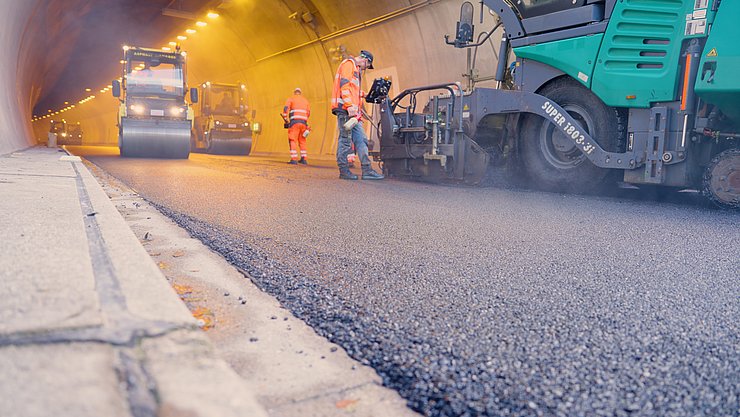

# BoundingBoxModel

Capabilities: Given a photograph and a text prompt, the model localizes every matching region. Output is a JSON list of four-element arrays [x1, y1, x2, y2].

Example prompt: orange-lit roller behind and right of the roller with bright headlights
[[192, 82, 252, 155]]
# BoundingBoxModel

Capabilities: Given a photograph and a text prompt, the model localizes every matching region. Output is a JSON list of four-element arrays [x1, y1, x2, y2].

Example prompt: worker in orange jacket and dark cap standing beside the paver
[[331, 51, 384, 180]]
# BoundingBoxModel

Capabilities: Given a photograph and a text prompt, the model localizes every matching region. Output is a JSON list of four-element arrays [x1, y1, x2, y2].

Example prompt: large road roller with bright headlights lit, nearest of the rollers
[[112, 46, 198, 159]]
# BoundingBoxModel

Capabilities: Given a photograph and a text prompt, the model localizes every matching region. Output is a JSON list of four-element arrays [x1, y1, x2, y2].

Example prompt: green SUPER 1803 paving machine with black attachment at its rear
[[378, 0, 740, 209]]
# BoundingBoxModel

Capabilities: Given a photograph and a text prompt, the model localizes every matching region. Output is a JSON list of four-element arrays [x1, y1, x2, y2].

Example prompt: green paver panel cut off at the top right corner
[[696, 0, 740, 123]]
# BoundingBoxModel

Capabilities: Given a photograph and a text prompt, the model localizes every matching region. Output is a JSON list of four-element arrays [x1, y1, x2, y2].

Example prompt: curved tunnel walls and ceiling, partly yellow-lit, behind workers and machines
[[0, 0, 496, 155]]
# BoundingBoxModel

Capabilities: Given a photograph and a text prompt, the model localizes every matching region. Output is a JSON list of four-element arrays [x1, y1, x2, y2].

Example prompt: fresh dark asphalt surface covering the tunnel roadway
[[72, 148, 740, 417]]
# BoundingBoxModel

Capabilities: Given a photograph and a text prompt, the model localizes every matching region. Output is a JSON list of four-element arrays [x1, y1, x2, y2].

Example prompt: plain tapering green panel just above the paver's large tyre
[[514, 33, 603, 87]]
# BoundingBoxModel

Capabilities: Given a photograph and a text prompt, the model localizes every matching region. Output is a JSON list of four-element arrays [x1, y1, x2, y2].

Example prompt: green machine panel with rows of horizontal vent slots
[[591, 0, 700, 108]]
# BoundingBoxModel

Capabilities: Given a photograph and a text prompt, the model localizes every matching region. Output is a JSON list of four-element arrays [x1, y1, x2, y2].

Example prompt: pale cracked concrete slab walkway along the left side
[[0, 148, 267, 417]]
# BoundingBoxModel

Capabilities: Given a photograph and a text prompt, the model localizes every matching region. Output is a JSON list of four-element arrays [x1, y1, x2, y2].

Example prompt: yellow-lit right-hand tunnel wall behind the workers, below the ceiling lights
[[23, 0, 500, 155]]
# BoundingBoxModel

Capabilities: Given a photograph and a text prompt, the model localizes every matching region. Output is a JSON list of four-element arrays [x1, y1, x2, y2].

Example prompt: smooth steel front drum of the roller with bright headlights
[[118, 119, 190, 159]]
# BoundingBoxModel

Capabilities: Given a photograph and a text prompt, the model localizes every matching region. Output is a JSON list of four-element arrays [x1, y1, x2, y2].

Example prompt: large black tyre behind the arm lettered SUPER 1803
[[520, 78, 626, 192]]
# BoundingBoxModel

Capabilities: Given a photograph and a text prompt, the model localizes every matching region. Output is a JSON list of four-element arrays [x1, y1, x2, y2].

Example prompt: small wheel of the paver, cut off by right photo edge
[[702, 149, 740, 209]]
